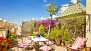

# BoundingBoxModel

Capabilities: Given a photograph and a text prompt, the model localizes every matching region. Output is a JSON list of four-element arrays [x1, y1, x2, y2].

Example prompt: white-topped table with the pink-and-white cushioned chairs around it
[[18, 35, 54, 51]]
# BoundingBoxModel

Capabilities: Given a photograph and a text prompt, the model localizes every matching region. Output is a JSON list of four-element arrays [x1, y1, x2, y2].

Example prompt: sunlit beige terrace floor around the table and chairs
[[7, 38, 88, 51]]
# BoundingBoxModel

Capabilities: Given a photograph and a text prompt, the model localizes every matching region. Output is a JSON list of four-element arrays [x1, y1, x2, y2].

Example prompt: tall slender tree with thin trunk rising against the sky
[[47, 2, 60, 34]]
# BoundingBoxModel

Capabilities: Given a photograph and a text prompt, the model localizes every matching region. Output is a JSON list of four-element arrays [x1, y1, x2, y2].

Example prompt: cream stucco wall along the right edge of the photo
[[86, 0, 91, 47]]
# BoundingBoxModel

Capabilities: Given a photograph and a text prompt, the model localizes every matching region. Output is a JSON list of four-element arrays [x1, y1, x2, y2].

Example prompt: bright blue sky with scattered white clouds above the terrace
[[0, 0, 86, 23]]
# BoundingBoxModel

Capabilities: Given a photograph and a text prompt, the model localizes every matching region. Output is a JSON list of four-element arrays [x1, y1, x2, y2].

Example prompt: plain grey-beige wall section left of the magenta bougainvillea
[[21, 20, 37, 34]]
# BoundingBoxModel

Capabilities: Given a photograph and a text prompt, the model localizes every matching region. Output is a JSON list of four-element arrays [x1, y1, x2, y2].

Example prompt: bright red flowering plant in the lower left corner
[[0, 37, 11, 51]]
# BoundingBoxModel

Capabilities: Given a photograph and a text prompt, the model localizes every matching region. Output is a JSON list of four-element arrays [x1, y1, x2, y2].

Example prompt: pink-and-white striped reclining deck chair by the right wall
[[67, 37, 87, 51]]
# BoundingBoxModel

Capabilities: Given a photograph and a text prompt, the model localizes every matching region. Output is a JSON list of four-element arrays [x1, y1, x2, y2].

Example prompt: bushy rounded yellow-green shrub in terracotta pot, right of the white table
[[50, 28, 62, 45]]
